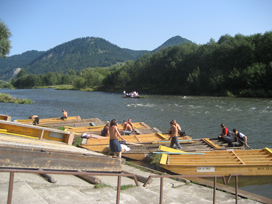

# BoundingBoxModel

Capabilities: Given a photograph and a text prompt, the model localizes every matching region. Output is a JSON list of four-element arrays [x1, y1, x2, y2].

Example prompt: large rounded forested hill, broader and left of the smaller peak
[[26, 37, 134, 74]]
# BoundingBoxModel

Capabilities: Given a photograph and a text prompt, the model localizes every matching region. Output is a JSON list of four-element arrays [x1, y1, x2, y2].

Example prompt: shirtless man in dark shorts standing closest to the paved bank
[[109, 119, 124, 158]]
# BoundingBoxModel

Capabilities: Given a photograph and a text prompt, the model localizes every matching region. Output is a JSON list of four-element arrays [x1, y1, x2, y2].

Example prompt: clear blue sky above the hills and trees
[[0, 0, 272, 56]]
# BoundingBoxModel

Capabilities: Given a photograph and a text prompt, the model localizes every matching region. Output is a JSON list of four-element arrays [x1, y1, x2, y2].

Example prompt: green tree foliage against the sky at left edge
[[0, 20, 11, 58]]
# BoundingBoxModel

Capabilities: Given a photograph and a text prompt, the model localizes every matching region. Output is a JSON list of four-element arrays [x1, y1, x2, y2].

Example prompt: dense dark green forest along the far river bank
[[9, 32, 272, 97]]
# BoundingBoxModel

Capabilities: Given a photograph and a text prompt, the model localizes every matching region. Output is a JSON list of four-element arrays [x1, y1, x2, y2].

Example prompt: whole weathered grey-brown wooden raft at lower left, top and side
[[0, 134, 124, 171]]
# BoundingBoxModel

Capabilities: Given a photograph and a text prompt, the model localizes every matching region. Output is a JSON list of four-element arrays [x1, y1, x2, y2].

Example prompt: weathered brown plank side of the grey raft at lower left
[[0, 147, 124, 171]]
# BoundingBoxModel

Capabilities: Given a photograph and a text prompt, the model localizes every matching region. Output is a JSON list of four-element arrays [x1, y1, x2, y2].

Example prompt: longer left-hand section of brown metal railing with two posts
[[0, 168, 139, 204]]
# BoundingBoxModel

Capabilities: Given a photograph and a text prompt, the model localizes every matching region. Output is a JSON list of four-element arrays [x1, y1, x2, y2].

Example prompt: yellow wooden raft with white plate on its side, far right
[[160, 148, 272, 176]]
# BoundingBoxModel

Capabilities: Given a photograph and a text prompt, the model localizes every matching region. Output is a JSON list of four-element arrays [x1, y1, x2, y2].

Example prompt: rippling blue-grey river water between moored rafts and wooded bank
[[0, 89, 272, 198]]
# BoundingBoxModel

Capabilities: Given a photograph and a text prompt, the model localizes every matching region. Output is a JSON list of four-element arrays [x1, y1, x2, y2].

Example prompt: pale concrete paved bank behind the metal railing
[[0, 165, 258, 204]]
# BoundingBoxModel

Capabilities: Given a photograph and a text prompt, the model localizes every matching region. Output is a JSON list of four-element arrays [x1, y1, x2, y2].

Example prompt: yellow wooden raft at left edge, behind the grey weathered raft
[[0, 120, 74, 145]]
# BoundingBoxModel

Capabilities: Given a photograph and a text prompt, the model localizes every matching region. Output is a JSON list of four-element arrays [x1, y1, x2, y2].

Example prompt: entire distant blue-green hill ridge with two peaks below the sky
[[0, 36, 192, 79]]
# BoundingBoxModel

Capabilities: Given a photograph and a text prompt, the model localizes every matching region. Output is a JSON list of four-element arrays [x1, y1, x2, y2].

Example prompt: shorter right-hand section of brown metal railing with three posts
[[144, 174, 241, 204]]
